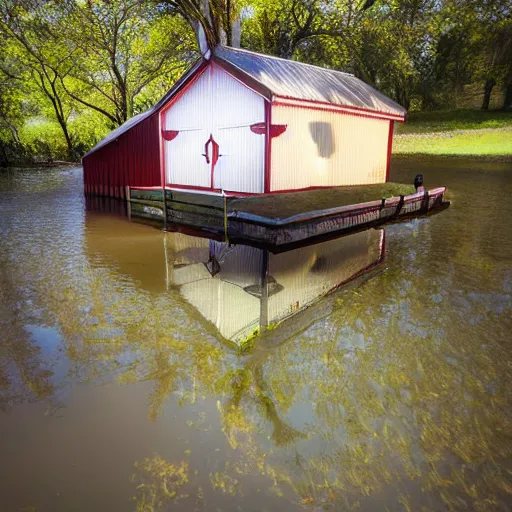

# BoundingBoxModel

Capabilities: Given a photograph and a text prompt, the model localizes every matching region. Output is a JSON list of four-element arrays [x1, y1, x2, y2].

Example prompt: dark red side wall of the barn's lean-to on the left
[[83, 115, 161, 199]]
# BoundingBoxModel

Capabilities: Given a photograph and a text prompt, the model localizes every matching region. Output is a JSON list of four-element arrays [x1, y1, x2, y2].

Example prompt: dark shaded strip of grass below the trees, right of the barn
[[395, 110, 512, 134]]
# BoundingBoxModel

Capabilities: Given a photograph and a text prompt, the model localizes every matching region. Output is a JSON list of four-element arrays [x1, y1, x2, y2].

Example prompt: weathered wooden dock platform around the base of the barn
[[128, 183, 449, 252]]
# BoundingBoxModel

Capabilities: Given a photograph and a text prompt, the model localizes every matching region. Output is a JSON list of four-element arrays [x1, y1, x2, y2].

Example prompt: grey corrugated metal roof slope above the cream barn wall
[[214, 46, 407, 116]]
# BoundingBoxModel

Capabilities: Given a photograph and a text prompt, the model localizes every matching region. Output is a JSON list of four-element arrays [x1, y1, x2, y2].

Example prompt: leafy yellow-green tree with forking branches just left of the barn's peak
[[60, 0, 195, 127]]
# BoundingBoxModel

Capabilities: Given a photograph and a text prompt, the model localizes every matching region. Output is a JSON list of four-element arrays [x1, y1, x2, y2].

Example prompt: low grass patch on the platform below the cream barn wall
[[229, 183, 414, 219]]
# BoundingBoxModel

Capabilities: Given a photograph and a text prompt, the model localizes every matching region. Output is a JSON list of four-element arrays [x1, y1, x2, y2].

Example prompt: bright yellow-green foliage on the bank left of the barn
[[0, 0, 195, 163]]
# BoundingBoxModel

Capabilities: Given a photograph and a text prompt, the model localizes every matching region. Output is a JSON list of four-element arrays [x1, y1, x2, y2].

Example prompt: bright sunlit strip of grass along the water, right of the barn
[[393, 127, 512, 157]]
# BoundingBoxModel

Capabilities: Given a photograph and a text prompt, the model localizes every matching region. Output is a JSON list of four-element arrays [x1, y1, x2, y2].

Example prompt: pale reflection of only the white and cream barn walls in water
[[166, 230, 384, 341]]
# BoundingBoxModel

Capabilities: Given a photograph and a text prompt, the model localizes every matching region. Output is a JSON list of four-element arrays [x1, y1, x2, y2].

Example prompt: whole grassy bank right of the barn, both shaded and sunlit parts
[[393, 110, 512, 158]]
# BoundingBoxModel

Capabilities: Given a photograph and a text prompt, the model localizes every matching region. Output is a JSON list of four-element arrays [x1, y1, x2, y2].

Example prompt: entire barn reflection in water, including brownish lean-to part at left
[[85, 200, 384, 341]]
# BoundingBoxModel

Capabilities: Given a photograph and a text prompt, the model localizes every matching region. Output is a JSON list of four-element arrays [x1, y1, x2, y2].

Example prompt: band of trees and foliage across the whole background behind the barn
[[0, 0, 512, 166]]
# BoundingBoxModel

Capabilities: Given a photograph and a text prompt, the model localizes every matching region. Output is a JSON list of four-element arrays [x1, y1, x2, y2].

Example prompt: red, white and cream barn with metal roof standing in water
[[83, 46, 406, 198]]
